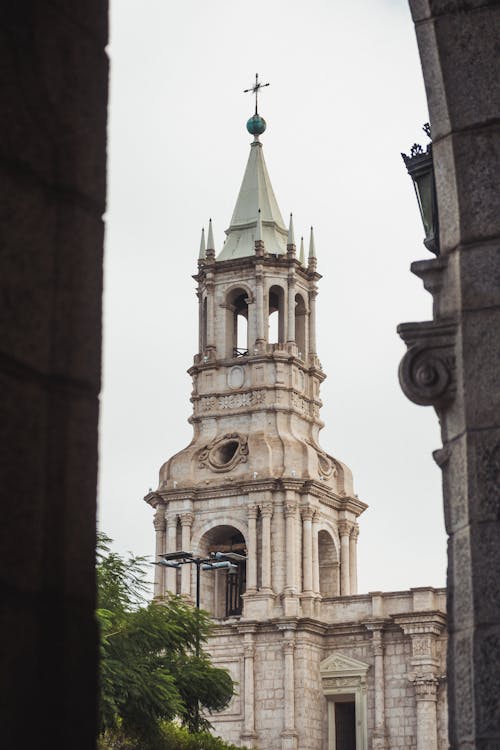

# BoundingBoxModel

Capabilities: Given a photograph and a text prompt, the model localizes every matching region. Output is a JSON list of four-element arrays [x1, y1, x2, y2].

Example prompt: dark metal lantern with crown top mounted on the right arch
[[401, 122, 439, 255]]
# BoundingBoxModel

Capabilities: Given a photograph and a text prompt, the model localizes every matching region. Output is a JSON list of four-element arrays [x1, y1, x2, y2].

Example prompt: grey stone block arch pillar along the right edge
[[407, 0, 500, 750]]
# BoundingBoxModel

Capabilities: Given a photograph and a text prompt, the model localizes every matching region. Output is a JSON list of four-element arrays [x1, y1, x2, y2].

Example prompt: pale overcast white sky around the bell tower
[[99, 0, 446, 593]]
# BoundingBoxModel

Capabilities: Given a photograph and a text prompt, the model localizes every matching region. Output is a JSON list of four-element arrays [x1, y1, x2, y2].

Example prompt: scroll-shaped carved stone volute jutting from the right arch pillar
[[398, 320, 456, 409]]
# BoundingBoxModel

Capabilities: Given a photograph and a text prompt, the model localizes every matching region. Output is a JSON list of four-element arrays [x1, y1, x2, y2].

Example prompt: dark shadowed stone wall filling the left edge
[[0, 0, 108, 750]]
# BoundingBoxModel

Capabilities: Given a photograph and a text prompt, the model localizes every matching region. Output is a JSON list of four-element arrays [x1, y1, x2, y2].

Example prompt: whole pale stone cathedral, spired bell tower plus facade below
[[145, 100, 443, 750]]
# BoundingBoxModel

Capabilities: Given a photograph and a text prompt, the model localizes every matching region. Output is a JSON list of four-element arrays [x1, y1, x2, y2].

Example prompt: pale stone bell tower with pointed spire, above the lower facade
[[145, 103, 366, 621]]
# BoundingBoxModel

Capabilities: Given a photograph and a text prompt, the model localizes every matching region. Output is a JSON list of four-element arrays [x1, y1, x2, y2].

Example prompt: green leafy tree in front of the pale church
[[97, 535, 238, 750]]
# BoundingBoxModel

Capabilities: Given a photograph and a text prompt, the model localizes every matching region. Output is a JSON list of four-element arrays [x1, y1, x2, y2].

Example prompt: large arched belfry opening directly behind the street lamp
[[199, 526, 246, 619]]
